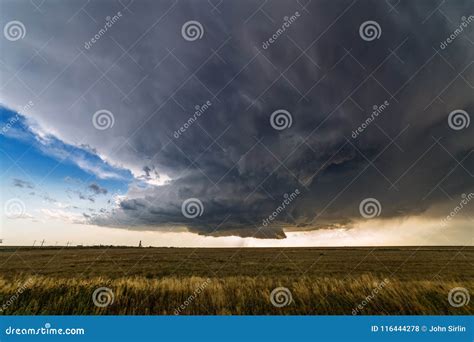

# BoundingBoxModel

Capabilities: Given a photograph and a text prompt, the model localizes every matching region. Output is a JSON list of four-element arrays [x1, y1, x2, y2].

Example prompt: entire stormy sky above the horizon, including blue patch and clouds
[[0, 0, 474, 247]]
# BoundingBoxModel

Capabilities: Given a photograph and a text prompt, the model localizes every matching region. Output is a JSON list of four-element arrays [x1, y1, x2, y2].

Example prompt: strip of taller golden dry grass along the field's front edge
[[0, 275, 474, 315]]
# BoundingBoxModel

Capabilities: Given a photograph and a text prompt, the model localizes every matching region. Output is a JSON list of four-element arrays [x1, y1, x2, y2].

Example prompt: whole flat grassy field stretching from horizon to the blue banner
[[0, 247, 474, 315]]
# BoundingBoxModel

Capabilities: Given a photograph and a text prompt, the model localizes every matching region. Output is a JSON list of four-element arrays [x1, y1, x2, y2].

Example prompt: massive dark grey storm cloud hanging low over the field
[[1, 1, 474, 238]]
